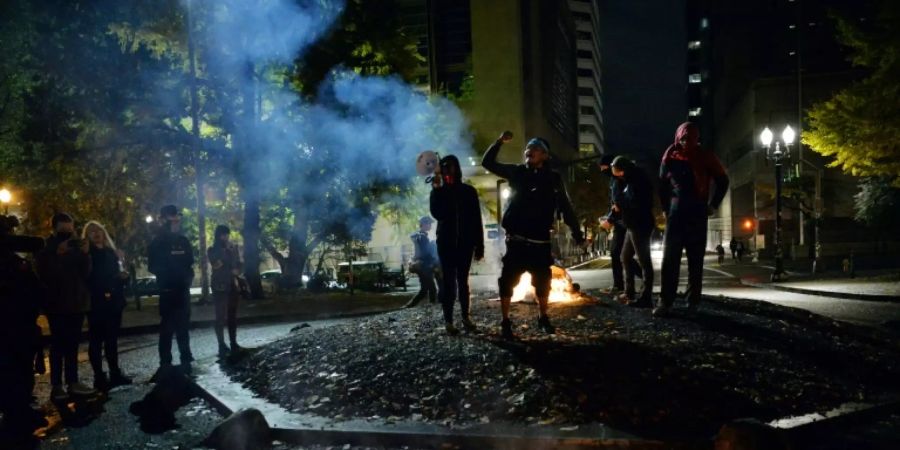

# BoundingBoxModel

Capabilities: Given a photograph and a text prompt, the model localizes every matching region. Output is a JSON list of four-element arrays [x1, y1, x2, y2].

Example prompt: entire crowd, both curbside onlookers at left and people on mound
[[0, 123, 742, 442]]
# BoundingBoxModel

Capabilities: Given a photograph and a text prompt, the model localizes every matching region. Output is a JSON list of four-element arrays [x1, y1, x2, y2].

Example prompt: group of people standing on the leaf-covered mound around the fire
[[407, 122, 742, 339]]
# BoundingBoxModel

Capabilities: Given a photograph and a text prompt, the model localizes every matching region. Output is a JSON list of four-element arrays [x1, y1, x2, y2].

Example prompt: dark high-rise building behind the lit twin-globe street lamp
[[685, 0, 870, 256]]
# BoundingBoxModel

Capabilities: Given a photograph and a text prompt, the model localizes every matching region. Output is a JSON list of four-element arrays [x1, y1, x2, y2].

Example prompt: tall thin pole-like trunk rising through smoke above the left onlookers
[[187, 0, 209, 301]]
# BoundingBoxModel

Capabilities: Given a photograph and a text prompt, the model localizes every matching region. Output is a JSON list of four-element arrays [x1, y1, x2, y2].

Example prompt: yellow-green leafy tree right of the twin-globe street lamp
[[803, 1, 900, 187]]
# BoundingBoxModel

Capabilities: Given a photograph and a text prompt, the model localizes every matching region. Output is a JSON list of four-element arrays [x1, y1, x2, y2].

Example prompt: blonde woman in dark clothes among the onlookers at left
[[82, 221, 131, 390]]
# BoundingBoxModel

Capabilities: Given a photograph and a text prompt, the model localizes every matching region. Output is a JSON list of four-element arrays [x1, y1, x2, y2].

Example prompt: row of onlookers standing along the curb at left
[[0, 205, 250, 442]]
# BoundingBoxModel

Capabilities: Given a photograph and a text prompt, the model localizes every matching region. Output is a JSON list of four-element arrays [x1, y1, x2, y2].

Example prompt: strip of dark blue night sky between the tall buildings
[[599, 0, 687, 172]]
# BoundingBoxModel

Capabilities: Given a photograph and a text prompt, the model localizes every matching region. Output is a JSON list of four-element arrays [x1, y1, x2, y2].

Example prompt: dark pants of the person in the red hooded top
[[660, 213, 706, 306]]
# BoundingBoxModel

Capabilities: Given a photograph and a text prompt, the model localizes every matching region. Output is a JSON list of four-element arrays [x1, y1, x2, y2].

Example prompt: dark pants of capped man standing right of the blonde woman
[[159, 288, 194, 366]]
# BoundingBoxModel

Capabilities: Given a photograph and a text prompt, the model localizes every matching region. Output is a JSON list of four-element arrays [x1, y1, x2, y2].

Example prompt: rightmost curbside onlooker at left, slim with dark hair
[[206, 225, 242, 358]]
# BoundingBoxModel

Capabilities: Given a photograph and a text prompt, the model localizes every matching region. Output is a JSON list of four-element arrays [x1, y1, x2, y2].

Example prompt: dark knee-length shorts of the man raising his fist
[[497, 240, 553, 298]]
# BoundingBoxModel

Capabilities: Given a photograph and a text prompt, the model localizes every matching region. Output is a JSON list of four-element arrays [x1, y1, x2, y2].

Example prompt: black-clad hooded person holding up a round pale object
[[430, 155, 484, 335]]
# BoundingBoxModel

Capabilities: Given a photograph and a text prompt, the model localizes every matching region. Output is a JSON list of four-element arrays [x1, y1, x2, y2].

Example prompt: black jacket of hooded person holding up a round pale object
[[430, 182, 484, 252]]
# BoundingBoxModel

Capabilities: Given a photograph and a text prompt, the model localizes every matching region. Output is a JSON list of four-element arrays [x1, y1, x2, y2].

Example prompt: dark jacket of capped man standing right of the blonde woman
[[147, 232, 194, 290]]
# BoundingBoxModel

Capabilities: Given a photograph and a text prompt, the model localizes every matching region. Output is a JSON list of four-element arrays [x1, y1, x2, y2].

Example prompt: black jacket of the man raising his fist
[[481, 141, 584, 244]]
